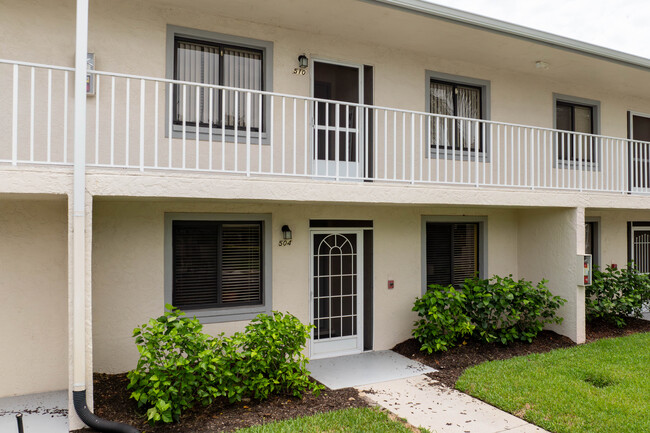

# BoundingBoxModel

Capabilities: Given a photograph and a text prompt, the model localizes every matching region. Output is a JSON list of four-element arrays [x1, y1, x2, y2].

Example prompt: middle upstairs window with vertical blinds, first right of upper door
[[427, 72, 489, 156]]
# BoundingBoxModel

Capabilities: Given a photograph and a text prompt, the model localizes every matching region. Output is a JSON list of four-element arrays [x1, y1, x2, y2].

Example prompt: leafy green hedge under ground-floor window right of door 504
[[413, 275, 566, 353]]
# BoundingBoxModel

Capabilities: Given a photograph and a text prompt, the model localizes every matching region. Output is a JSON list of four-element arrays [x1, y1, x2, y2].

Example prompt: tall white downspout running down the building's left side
[[72, 0, 88, 391]]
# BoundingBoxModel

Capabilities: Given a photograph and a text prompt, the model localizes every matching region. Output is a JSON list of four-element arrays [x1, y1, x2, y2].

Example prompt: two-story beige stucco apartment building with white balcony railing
[[0, 0, 650, 428]]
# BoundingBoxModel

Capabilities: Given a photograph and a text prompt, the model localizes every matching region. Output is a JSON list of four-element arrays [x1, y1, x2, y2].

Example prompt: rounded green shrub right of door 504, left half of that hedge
[[413, 284, 474, 353]]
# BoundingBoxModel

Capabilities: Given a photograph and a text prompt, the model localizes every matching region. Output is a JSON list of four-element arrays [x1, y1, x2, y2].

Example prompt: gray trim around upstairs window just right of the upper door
[[424, 70, 491, 162]]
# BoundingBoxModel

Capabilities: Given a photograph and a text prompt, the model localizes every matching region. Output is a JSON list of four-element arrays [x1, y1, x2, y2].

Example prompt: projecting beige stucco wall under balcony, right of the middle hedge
[[518, 208, 585, 343]]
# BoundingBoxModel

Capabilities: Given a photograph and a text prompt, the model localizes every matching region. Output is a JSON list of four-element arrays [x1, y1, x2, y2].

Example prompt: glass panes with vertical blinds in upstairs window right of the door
[[429, 80, 483, 152]]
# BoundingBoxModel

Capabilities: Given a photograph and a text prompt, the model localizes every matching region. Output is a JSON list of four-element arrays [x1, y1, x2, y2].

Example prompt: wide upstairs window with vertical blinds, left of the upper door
[[173, 37, 264, 131]]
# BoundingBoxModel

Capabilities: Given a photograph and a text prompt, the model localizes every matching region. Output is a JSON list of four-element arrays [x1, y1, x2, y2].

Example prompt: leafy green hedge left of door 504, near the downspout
[[127, 305, 321, 423]]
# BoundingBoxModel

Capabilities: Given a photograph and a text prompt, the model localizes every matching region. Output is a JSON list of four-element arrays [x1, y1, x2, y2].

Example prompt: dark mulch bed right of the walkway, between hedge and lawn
[[393, 319, 650, 388]]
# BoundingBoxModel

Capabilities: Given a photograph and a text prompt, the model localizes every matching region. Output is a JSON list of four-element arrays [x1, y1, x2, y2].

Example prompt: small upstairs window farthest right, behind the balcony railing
[[555, 96, 598, 162]]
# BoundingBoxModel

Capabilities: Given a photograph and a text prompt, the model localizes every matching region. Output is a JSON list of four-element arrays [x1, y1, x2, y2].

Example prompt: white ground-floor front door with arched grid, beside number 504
[[310, 230, 363, 358]]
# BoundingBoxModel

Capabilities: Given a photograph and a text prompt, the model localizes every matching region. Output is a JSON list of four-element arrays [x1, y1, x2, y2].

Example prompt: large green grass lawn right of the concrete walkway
[[456, 333, 650, 433]]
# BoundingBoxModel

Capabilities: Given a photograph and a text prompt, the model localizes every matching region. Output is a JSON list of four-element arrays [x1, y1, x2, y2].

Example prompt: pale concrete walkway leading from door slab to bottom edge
[[356, 375, 545, 433]]
